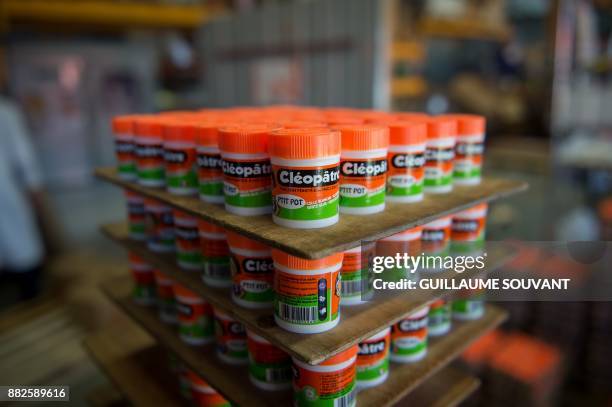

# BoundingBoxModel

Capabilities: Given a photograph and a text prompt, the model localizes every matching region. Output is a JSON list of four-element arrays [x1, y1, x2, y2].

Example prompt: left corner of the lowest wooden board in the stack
[[84, 324, 185, 407]]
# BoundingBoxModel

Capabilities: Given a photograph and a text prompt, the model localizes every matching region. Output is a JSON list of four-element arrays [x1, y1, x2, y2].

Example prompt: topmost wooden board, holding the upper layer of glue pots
[[96, 168, 527, 259]]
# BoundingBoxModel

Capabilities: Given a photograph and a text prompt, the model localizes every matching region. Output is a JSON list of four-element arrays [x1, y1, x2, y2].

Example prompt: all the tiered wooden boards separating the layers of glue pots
[[86, 164, 526, 406]]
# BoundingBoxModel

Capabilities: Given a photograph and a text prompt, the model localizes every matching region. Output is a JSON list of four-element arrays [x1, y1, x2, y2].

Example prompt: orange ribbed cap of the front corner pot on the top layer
[[270, 128, 340, 160]]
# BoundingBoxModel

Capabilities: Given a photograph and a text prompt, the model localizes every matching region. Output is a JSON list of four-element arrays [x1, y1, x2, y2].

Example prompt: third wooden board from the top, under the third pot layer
[[105, 285, 500, 406]]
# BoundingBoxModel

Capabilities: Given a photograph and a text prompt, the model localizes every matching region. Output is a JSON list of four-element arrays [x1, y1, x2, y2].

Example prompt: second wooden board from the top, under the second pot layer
[[102, 223, 511, 364]]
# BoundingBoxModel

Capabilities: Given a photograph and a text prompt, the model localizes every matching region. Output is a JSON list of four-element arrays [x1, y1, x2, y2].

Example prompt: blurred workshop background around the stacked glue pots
[[0, 0, 612, 405]]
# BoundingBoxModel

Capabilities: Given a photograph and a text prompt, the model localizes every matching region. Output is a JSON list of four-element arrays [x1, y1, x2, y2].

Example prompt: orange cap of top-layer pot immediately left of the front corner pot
[[219, 124, 275, 154]]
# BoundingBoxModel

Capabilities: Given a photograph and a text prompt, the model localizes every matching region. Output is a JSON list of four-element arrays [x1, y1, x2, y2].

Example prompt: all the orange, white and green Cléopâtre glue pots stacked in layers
[[113, 107, 487, 406]]
